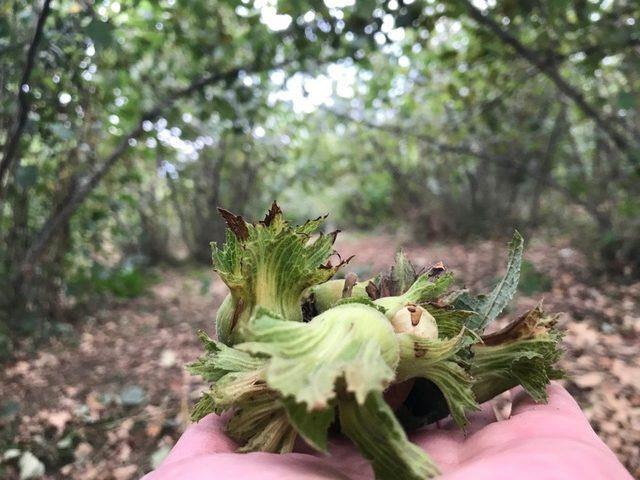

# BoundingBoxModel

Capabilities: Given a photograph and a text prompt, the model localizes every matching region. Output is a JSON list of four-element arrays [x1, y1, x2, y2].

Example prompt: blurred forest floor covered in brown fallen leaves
[[0, 235, 640, 480]]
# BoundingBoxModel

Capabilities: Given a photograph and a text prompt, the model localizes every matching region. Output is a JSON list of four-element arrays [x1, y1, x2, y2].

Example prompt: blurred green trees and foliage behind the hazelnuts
[[0, 0, 640, 350]]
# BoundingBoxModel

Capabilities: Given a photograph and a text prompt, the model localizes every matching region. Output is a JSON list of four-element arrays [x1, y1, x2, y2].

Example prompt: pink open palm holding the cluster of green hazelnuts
[[143, 384, 632, 480]]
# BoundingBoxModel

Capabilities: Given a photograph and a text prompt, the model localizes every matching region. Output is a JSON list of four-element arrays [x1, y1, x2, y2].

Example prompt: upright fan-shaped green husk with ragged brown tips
[[212, 203, 342, 344]]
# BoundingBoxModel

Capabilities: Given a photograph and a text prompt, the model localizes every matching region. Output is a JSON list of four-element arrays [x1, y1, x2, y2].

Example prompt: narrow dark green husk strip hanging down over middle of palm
[[338, 392, 439, 480]]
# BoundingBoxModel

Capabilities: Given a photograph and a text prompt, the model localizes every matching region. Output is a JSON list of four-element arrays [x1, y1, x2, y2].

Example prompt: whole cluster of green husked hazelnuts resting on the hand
[[189, 208, 561, 480]]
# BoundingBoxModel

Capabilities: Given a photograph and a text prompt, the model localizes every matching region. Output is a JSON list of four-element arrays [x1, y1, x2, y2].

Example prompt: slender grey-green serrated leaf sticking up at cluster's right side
[[462, 231, 524, 332]]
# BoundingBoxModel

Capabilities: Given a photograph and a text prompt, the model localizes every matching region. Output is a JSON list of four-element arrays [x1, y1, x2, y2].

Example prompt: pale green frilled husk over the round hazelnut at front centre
[[237, 303, 398, 411]]
